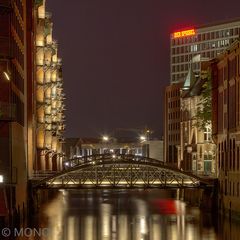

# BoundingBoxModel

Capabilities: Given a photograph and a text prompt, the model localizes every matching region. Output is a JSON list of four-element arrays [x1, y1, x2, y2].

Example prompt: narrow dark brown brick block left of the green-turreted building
[[164, 82, 183, 167]]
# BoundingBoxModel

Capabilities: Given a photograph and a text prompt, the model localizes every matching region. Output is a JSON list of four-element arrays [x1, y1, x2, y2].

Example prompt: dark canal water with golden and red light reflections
[[29, 190, 240, 240]]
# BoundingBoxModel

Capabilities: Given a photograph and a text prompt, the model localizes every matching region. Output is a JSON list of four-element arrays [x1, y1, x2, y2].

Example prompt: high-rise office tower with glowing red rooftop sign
[[170, 19, 240, 83]]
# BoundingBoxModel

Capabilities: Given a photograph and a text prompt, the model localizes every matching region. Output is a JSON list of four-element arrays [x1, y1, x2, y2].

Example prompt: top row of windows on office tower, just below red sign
[[172, 27, 239, 45]]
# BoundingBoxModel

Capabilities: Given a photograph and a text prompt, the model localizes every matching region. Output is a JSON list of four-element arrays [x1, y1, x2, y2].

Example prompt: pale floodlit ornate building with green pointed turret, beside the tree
[[178, 62, 216, 175]]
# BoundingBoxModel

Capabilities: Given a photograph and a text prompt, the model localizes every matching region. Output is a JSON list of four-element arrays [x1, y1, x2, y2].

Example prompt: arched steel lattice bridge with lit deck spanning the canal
[[34, 154, 214, 189]]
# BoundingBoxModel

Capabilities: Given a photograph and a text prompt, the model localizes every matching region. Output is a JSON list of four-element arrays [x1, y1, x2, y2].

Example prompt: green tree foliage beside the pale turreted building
[[195, 71, 212, 130]]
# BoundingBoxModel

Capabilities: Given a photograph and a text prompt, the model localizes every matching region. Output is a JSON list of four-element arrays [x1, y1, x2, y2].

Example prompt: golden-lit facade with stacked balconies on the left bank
[[33, 0, 65, 173]]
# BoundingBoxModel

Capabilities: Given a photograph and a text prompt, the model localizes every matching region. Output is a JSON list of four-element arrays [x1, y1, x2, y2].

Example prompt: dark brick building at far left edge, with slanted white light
[[0, 0, 27, 219]]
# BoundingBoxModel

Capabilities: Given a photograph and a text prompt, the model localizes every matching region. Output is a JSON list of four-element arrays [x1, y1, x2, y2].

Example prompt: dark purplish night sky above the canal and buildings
[[47, 0, 240, 137]]
